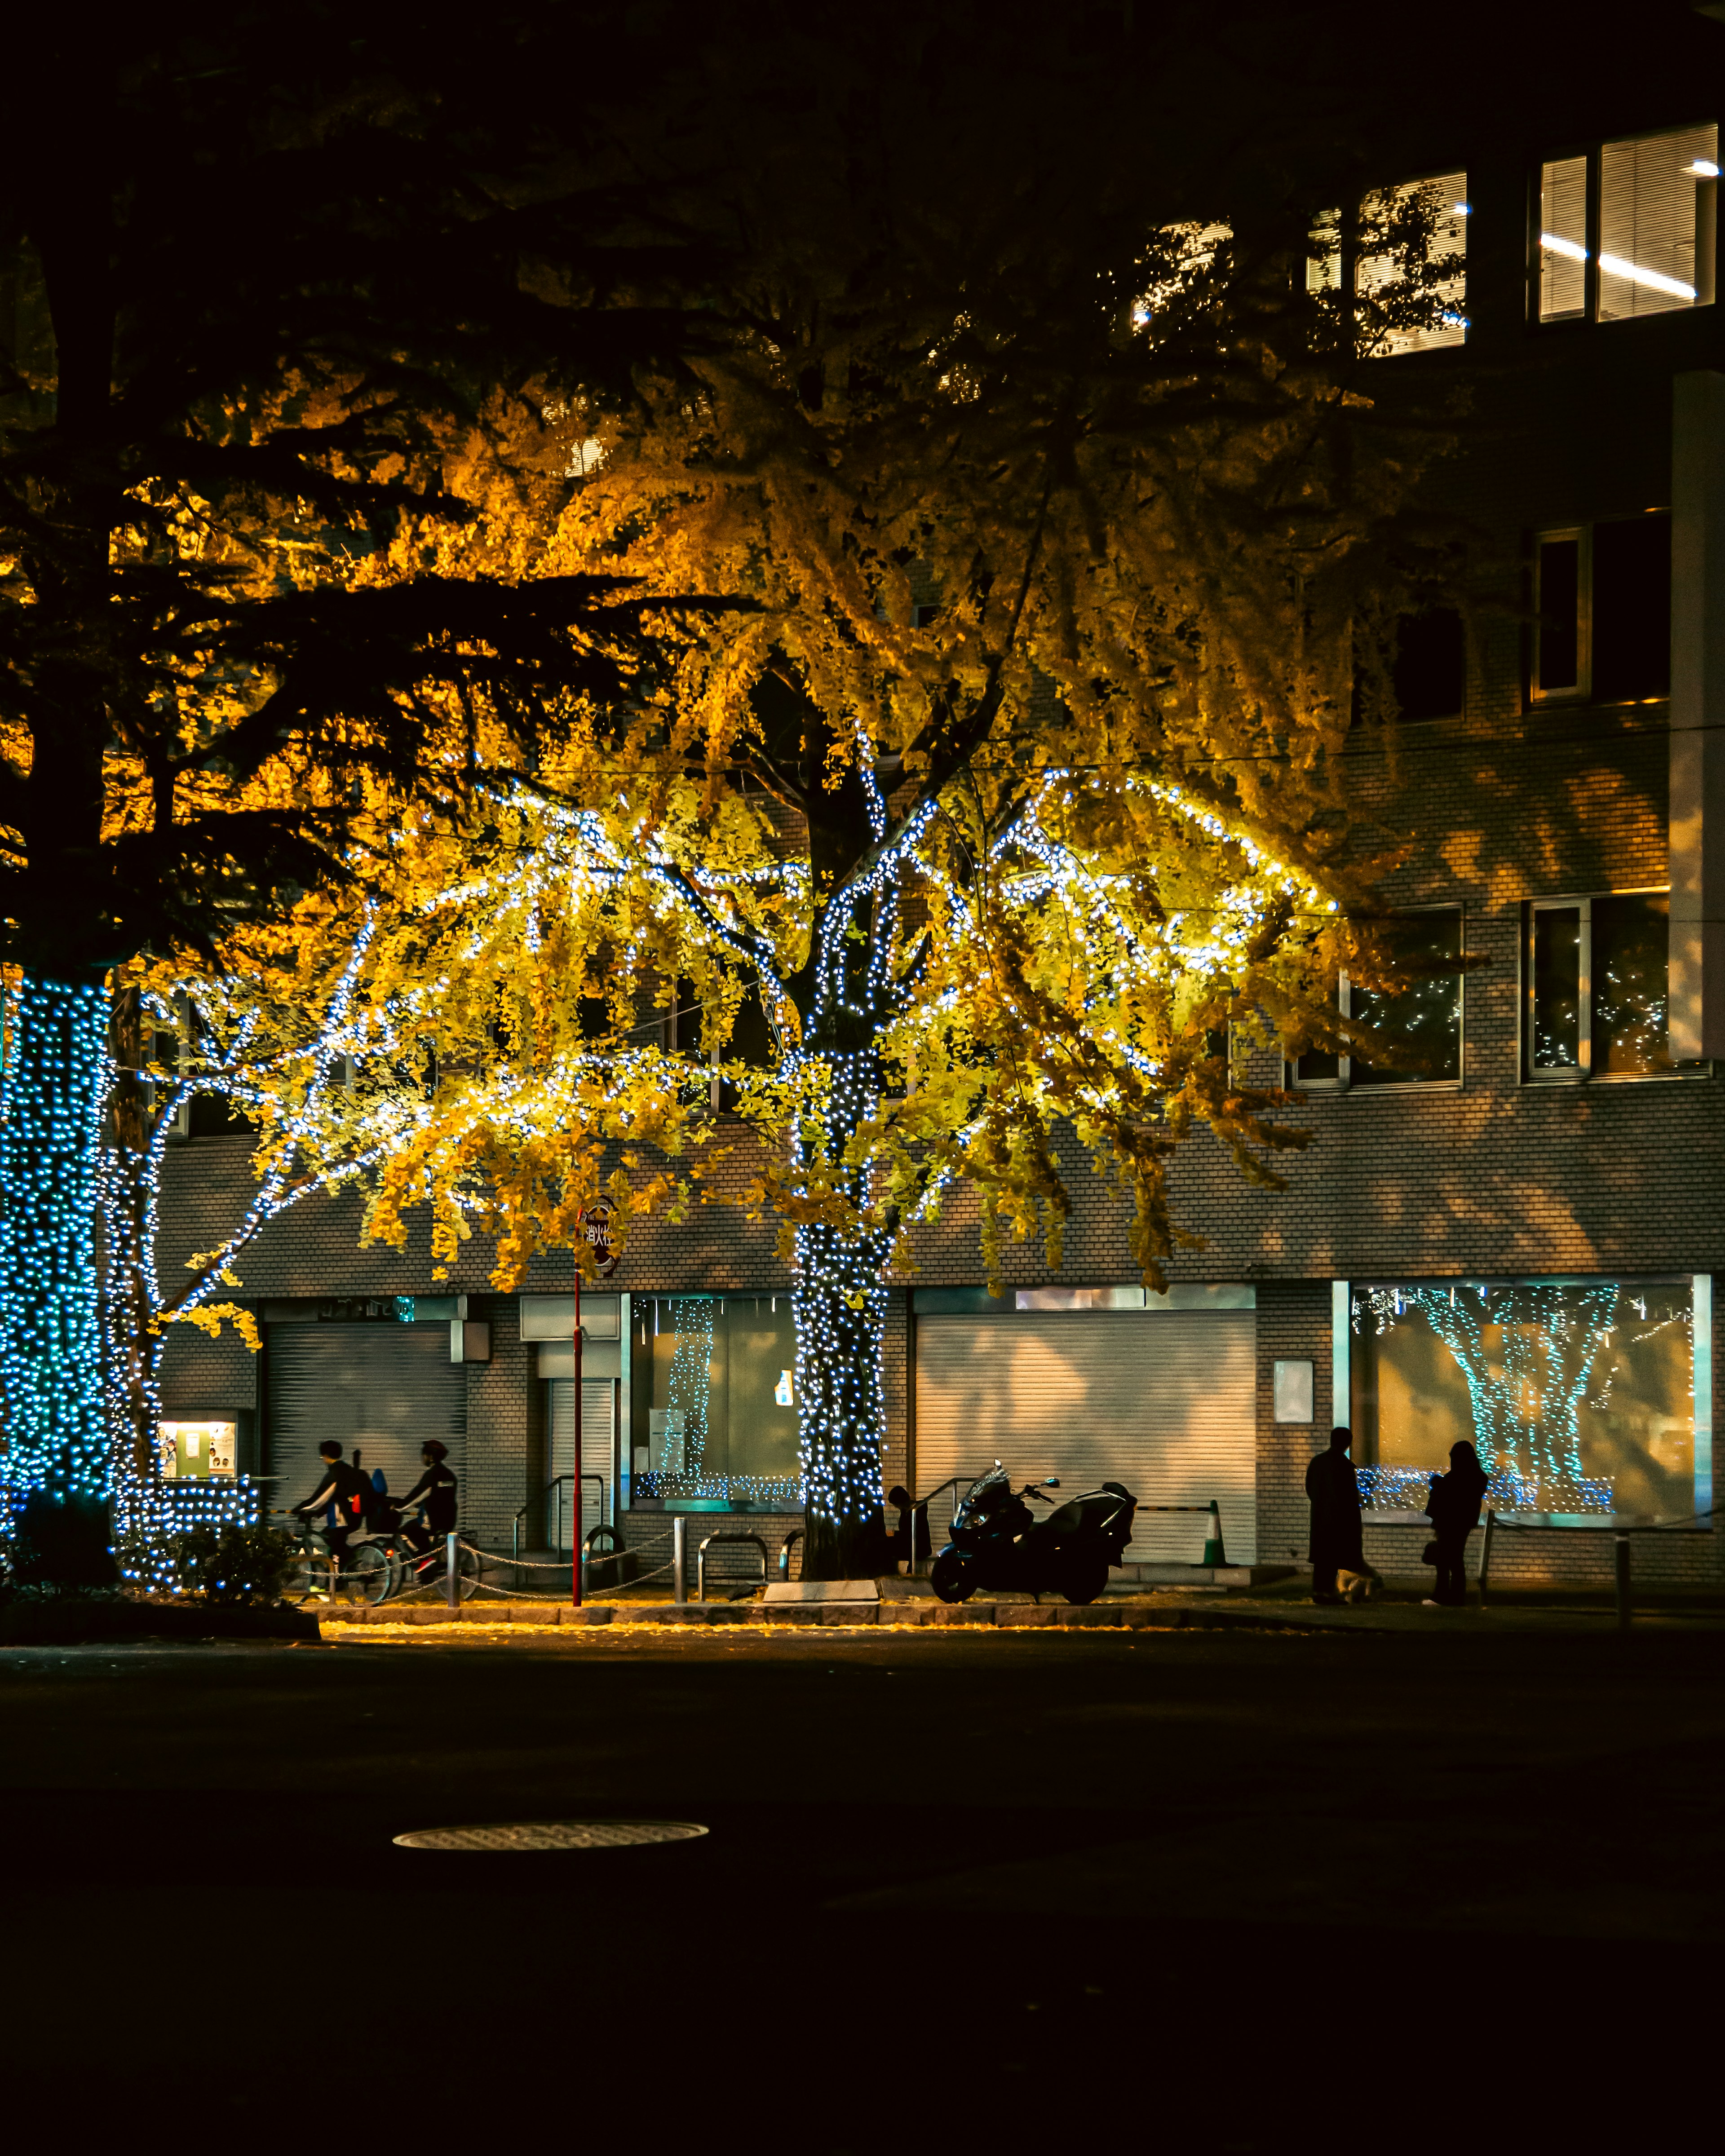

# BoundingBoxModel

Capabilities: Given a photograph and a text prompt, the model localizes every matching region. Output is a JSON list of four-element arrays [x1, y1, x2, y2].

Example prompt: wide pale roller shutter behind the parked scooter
[[916, 1311, 1257, 1563]]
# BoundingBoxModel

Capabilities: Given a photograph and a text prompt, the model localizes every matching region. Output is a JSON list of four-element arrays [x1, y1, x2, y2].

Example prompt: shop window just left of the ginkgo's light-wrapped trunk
[[630, 1296, 802, 1511]]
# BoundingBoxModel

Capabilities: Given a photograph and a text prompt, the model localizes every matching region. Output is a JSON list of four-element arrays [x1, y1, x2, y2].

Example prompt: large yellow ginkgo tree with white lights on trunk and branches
[[121, 8, 1475, 1576]]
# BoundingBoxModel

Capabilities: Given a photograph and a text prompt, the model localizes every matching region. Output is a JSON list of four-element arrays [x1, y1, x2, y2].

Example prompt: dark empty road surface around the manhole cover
[[0, 1630, 1725, 2156]]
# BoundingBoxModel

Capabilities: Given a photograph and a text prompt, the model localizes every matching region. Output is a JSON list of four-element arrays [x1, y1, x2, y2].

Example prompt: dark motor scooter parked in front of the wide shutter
[[929, 1460, 1138, 1602]]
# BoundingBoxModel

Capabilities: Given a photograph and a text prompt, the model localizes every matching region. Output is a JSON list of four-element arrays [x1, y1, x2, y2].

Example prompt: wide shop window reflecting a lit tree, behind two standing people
[[1348, 1274, 1712, 1522]]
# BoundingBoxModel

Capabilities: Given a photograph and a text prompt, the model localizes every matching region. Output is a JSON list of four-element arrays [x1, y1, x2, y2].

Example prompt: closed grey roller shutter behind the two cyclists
[[265, 1324, 468, 1514]]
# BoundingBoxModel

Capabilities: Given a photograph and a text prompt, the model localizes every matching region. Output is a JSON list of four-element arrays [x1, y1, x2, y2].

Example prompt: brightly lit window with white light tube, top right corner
[[1537, 125, 1719, 321]]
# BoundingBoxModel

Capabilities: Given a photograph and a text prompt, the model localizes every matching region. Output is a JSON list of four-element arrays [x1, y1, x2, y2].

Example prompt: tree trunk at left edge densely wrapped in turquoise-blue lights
[[0, 972, 108, 1505]]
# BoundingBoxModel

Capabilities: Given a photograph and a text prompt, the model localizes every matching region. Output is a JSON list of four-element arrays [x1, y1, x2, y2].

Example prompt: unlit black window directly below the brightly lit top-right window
[[1529, 511, 1671, 703]]
